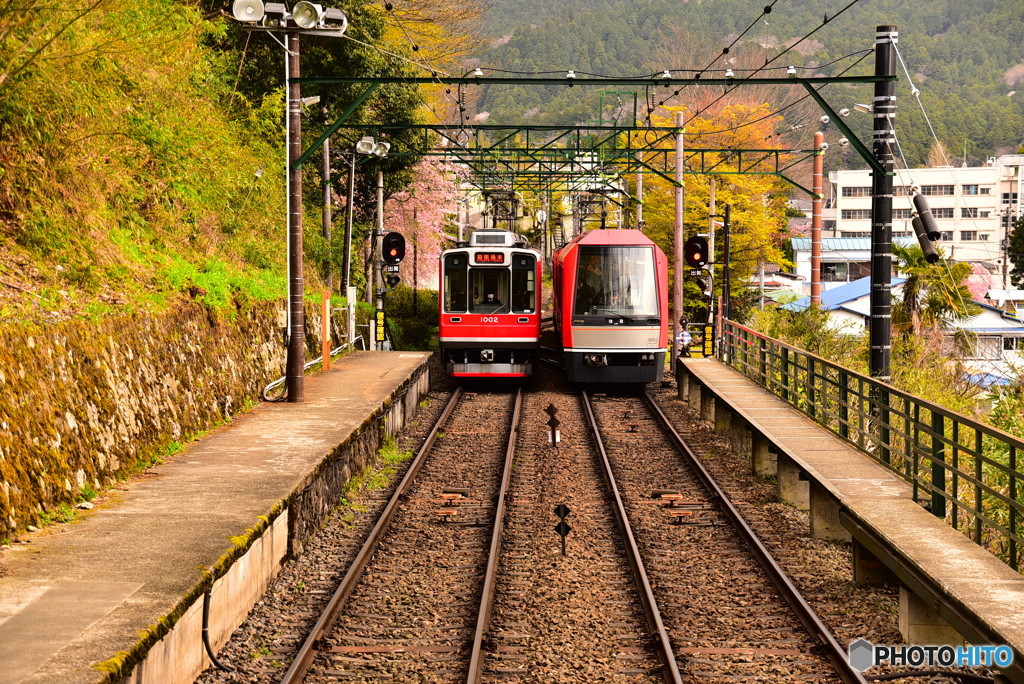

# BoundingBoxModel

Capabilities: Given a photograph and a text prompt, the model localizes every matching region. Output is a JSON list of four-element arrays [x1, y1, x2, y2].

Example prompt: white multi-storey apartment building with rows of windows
[[828, 155, 1024, 289]]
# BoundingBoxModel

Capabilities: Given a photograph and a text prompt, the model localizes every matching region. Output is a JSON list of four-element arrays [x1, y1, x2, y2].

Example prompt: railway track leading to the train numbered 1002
[[282, 391, 521, 682]]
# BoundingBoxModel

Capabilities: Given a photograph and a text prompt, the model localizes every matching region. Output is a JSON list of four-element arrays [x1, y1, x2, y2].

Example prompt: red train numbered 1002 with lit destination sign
[[438, 229, 542, 378]]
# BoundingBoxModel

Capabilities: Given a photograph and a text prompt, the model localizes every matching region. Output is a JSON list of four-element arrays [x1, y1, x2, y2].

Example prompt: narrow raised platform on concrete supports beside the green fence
[[677, 358, 1024, 682]]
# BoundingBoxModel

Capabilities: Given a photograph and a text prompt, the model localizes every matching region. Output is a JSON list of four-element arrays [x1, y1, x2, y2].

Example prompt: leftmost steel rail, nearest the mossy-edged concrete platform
[[281, 387, 463, 684]]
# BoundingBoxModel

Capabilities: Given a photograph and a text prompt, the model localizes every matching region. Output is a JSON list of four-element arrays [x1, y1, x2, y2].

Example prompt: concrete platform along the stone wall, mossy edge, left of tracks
[[0, 352, 429, 684]]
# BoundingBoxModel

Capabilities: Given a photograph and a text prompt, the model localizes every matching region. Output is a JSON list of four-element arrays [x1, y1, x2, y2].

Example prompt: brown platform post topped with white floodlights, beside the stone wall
[[231, 0, 348, 402]]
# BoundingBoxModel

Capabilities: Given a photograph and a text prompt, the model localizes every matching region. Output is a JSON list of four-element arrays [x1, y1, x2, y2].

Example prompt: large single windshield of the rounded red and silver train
[[572, 246, 658, 317]]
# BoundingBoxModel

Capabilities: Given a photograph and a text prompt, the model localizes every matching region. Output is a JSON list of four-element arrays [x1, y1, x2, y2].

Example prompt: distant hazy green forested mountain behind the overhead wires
[[470, 0, 1024, 165]]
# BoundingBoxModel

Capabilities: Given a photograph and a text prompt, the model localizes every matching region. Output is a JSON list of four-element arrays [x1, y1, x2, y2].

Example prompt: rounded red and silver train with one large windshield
[[553, 230, 669, 383]]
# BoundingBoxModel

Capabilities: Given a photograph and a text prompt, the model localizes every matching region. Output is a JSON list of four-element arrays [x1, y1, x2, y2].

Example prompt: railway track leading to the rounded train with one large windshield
[[583, 393, 864, 682]]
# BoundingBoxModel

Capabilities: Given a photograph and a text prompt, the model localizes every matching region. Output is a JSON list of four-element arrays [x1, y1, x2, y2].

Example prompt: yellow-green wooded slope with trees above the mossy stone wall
[[0, 0, 477, 323]]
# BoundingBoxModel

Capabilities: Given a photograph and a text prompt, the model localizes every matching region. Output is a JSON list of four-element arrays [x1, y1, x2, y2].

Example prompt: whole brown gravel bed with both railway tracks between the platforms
[[203, 375, 876, 684]]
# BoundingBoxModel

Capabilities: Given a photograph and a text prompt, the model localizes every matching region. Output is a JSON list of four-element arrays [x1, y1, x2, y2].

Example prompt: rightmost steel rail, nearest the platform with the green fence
[[644, 392, 867, 684]]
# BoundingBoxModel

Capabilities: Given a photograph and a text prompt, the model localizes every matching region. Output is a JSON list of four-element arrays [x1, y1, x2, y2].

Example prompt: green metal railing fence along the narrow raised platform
[[719, 320, 1024, 570]]
